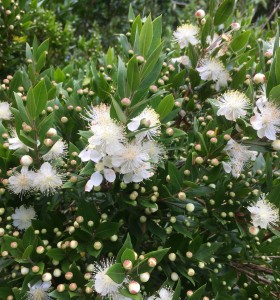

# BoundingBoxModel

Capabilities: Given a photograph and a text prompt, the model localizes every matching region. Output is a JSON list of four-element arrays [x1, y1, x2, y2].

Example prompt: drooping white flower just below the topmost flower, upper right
[[196, 58, 229, 91]]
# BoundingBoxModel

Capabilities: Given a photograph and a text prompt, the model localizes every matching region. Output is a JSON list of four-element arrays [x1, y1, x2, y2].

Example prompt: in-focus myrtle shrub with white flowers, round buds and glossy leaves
[[0, 0, 280, 300]]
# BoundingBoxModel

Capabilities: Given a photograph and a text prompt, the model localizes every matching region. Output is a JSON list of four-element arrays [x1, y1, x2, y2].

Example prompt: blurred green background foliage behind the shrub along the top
[[0, 0, 279, 79]]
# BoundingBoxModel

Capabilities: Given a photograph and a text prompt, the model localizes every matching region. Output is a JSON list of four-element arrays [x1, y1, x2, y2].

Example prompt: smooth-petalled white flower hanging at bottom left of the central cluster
[[85, 156, 116, 192]]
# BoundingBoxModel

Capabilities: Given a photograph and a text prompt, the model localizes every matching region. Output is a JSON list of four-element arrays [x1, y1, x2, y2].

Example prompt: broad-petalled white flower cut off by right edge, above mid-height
[[250, 99, 280, 141]]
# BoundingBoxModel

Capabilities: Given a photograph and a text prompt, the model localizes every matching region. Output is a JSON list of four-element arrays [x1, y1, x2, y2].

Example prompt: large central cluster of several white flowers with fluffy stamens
[[79, 104, 164, 191]]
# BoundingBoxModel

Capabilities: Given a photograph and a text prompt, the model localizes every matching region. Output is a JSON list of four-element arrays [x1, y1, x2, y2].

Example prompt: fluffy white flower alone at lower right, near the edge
[[248, 194, 279, 228]]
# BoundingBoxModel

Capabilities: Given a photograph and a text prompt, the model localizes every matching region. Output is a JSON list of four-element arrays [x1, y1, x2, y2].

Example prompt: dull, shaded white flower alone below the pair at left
[[12, 205, 36, 230]]
